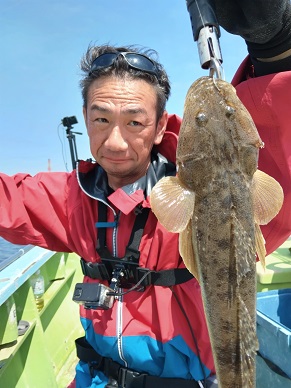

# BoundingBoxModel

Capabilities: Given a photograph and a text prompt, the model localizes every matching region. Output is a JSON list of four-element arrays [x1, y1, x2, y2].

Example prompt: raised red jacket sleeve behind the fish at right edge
[[233, 62, 291, 253]]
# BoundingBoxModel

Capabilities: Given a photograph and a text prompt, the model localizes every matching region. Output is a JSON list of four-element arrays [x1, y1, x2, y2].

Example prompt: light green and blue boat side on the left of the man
[[0, 246, 83, 388]]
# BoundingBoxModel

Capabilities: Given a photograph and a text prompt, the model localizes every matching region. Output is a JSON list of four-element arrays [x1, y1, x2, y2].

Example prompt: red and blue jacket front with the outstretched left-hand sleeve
[[0, 116, 214, 386]]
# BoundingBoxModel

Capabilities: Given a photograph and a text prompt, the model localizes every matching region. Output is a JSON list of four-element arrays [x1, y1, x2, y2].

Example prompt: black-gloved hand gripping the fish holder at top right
[[214, 0, 291, 58]]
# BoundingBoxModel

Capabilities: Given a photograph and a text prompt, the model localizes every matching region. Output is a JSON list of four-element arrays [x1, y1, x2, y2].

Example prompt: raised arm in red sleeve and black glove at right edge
[[214, 0, 291, 253]]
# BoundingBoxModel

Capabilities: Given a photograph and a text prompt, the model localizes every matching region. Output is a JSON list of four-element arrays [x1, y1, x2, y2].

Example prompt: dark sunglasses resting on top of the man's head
[[89, 52, 159, 80]]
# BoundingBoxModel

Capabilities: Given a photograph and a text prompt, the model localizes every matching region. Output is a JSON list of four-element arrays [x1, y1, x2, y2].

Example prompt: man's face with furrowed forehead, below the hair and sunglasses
[[83, 77, 168, 189]]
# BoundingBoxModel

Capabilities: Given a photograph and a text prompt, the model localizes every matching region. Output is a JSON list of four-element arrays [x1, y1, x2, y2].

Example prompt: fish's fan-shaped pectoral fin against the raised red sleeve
[[252, 170, 284, 225]]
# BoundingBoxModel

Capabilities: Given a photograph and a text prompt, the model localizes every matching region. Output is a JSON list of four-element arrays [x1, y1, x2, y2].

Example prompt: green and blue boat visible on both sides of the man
[[0, 239, 291, 388]]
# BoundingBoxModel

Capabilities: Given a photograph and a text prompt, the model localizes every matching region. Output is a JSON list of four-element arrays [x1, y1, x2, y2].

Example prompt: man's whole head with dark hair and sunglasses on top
[[81, 46, 170, 189]]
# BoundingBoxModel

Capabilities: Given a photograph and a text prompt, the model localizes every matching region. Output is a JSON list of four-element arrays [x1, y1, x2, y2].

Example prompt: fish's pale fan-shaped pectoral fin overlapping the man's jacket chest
[[150, 176, 195, 233]]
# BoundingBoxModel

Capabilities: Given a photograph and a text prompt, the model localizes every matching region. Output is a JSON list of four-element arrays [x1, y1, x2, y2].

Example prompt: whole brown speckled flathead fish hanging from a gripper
[[150, 76, 284, 388]]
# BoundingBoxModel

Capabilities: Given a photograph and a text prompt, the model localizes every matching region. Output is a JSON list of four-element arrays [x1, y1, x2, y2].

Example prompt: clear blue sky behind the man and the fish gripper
[[0, 0, 247, 175]]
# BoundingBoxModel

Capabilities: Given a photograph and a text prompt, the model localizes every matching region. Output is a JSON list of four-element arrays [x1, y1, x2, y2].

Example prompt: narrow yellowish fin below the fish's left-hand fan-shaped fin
[[179, 220, 199, 281]]
